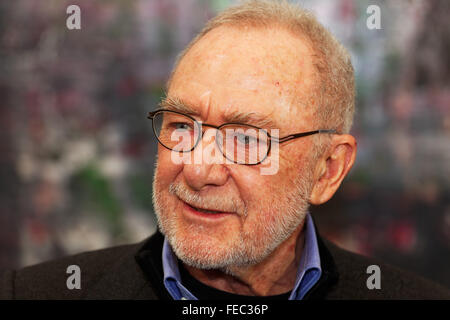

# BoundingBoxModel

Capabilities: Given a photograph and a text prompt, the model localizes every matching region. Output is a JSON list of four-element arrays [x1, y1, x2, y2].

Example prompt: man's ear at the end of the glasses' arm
[[309, 134, 356, 205]]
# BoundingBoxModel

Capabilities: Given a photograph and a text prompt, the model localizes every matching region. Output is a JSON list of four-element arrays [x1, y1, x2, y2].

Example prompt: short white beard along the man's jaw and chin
[[153, 161, 312, 274]]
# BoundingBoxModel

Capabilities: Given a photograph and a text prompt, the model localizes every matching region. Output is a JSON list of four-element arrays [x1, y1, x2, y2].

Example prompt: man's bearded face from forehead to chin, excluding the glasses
[[153, 27, 317, 270]]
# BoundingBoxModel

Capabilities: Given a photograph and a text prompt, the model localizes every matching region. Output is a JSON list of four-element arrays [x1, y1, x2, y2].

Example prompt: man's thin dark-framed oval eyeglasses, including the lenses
[[147, 109, 336, 165]]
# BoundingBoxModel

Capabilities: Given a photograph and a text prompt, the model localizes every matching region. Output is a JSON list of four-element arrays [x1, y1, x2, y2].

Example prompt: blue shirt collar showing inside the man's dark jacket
[[162, 213, 322, 300]]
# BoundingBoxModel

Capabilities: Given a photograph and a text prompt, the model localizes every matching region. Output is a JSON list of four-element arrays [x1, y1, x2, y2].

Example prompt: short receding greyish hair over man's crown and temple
[[168, 0, 355, 133]]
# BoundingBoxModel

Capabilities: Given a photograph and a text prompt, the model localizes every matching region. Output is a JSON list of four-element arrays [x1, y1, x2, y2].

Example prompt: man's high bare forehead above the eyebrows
[[168, 26, 315, 130]]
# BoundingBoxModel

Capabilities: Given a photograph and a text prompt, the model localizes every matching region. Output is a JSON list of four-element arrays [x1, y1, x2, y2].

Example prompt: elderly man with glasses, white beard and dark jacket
[[0, 1, 449, 300]]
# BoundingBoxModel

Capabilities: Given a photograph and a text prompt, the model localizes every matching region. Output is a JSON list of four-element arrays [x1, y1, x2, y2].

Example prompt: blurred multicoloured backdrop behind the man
[[0, 0, 450, 287]]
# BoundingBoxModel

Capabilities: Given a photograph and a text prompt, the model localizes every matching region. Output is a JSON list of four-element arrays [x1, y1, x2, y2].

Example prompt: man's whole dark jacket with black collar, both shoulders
[[0, 232, 450, 299]]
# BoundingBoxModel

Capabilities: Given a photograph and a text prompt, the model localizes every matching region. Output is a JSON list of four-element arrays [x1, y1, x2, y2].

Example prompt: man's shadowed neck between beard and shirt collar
[[184, 223, 304, 296]]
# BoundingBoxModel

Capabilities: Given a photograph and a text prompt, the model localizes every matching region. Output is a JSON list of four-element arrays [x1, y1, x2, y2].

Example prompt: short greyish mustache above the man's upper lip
[[169, 183, 247, 217]]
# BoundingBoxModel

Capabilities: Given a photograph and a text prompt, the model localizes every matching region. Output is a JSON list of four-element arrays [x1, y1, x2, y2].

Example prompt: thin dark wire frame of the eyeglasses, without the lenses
[[147, 109, 337, 166]]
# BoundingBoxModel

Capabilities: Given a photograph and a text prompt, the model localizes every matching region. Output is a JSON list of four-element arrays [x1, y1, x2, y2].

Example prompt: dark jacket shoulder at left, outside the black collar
[[0, 243, 156, 300]]
